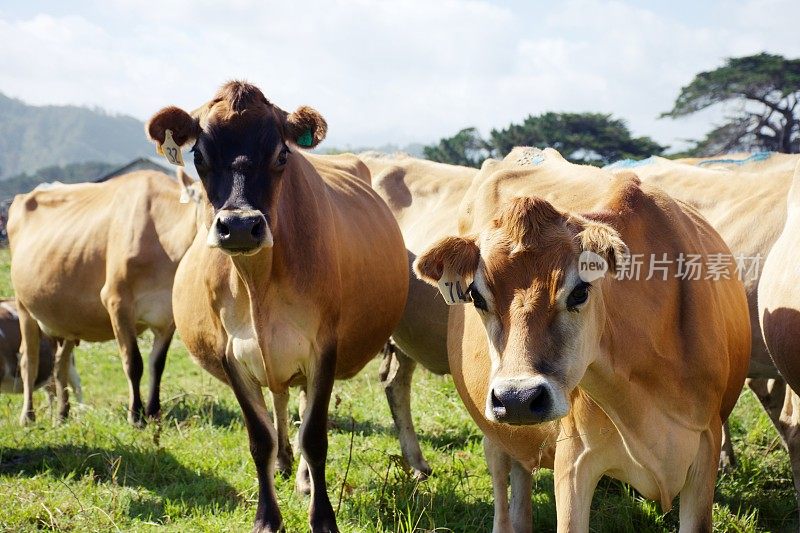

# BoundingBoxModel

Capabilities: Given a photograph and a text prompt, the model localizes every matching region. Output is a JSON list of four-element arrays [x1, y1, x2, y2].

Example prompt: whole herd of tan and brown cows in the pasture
[[0, 82, 800, 532]]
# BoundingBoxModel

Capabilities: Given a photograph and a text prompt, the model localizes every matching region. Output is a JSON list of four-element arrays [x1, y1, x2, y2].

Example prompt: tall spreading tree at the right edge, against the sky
[[661, 52, 800, 155]]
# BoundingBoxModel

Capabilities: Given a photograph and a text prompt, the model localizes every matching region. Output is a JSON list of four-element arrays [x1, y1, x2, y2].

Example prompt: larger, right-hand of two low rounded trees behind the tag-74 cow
[[489, 112, 666, 165]]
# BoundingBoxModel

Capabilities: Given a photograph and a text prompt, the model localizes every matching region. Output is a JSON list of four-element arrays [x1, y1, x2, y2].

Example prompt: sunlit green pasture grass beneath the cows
[[0, 247, 798, 532]]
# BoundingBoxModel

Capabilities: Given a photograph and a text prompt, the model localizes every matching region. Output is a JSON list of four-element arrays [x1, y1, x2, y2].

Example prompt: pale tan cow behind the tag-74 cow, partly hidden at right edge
[[612, 154, 800, 512]]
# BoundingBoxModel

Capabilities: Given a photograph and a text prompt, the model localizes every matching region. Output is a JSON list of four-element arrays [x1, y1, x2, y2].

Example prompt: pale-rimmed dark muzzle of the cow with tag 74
[[485, 376, 569, 425]]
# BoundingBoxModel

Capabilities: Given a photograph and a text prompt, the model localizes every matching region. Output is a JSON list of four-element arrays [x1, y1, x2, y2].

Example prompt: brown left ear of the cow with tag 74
[[414, 236, 481, 286]]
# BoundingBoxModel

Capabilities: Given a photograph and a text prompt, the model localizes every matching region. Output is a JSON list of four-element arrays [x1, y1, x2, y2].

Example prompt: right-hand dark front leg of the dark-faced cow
[[300, 349, 339, 533]]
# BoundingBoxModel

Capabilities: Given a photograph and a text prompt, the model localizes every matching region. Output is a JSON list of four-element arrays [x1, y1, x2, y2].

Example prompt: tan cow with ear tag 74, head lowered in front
[[415, 150, 750, 531]]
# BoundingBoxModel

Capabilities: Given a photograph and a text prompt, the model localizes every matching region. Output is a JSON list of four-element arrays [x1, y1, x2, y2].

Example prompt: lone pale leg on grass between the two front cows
[[380, 341, 431, 480]]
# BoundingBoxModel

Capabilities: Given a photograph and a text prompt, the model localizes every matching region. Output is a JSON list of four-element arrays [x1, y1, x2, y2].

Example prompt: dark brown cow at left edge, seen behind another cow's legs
[[0, 298, 83, 404]]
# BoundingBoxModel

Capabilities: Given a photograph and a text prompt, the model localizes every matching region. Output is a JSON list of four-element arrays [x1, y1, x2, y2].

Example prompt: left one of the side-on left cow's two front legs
[[100, 294, 144, 427]]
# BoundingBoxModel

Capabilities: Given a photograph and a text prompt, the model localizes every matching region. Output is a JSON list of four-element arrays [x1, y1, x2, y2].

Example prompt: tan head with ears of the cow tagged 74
[[414, 198, 626, 424]]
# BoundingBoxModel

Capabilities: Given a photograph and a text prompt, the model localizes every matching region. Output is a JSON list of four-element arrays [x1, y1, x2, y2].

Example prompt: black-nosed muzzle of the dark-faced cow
[[207, 209, 273, 255]]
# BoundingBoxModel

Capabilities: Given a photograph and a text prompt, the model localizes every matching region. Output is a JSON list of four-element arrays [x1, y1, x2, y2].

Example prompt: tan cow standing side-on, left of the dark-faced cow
[[8, 171, 197, 424]]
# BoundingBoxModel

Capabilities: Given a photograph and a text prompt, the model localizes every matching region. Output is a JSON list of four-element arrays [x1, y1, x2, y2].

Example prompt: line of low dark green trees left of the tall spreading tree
[[424, 113, 666, 167]]
